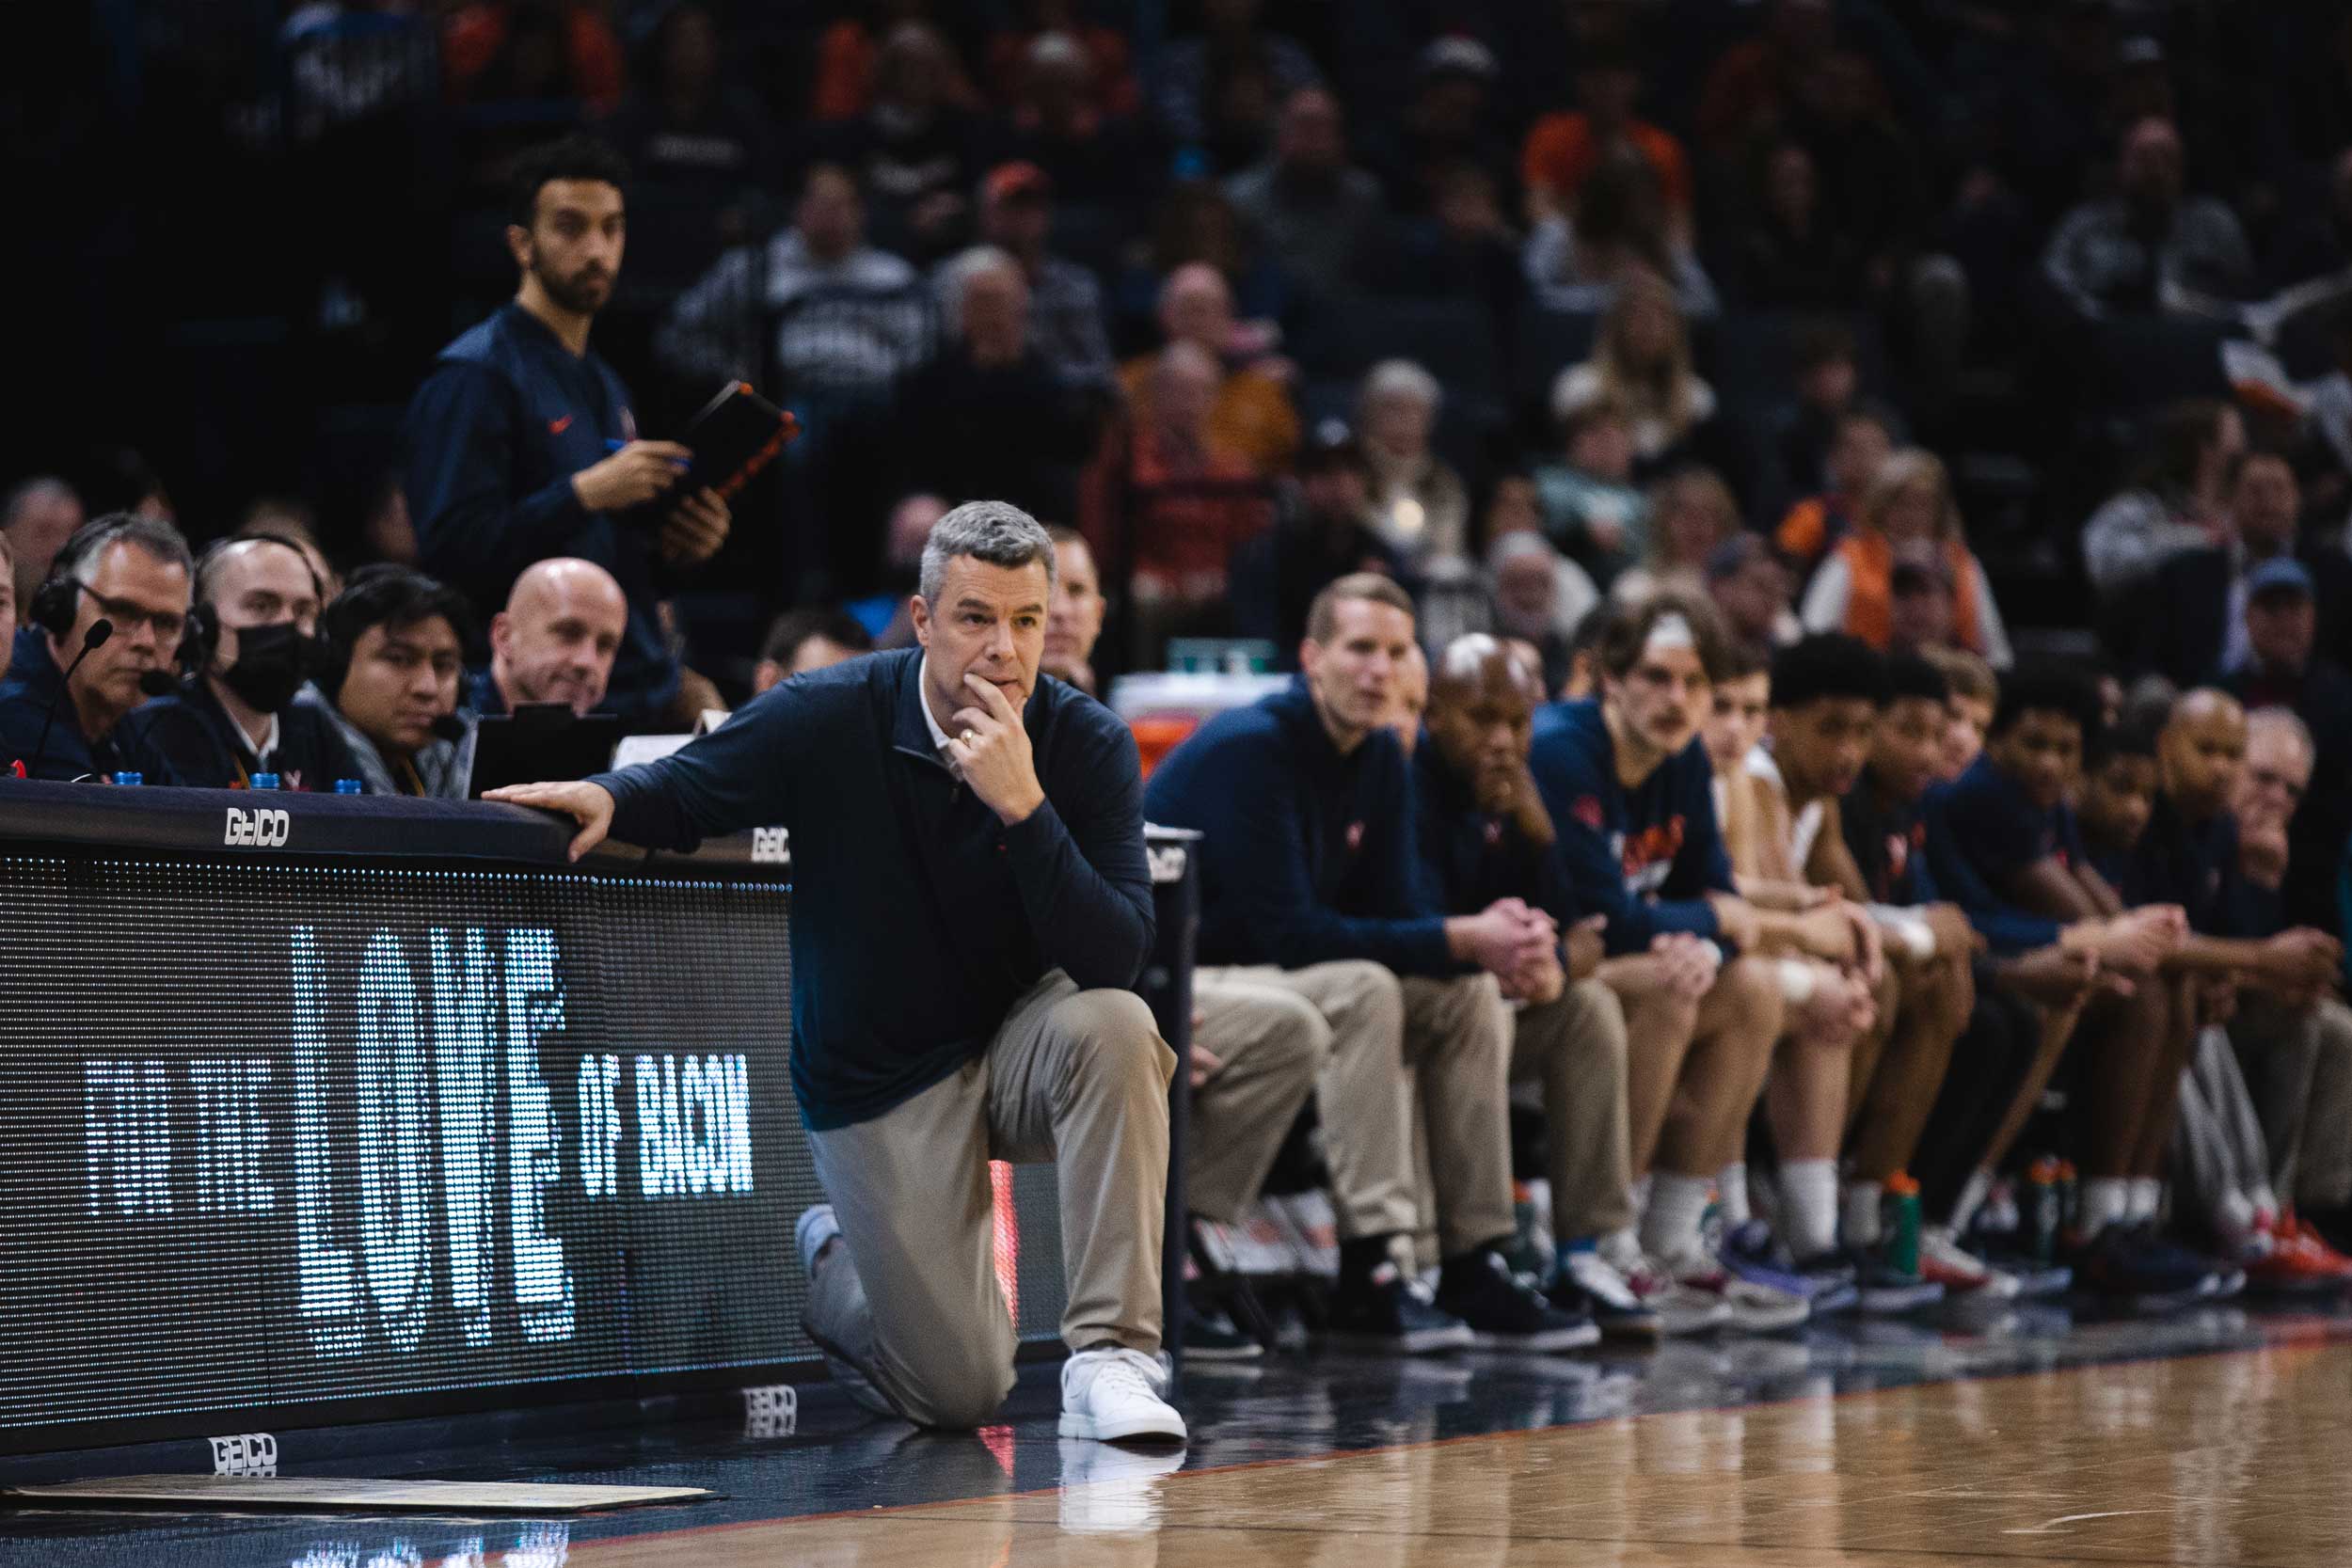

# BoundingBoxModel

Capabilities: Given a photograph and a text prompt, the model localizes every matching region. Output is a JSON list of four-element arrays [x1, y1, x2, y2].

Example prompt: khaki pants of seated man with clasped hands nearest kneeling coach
[[1188, 961, 1513, 1256]]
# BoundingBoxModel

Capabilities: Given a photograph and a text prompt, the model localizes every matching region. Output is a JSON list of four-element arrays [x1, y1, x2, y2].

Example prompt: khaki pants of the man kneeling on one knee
[[804, 969, 1176, 1427]]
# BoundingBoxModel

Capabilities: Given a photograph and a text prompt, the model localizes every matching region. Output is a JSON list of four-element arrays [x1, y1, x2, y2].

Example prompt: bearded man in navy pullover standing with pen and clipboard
[[403, 136, 729, 729]]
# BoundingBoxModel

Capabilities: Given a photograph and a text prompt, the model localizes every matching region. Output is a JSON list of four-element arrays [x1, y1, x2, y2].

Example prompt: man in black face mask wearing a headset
[[125, 533, 360, 792]]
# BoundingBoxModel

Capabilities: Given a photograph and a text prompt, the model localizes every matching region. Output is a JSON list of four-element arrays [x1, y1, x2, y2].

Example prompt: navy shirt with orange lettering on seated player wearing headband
[[1527, 703, 1734, 955]]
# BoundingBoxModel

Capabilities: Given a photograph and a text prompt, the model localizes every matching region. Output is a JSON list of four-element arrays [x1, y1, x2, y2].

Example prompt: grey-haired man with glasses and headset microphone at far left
[[0, 513, 196, 785]]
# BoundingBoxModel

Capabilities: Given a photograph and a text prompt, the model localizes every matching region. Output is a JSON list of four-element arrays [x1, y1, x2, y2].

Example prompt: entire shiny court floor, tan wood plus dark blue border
[[0, 1307, 2352, 1568]]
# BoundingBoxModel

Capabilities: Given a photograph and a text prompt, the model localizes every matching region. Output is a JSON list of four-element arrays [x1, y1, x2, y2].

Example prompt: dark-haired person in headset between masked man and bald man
[[294, 564, 473, 800]]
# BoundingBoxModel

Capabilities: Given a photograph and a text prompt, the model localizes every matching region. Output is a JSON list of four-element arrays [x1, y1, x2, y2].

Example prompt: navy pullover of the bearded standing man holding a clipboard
[[403, 303, 677, 721]]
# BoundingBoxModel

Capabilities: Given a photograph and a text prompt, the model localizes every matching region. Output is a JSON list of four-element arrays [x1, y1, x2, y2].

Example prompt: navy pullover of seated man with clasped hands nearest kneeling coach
[[1143, 682, 1463, 975]]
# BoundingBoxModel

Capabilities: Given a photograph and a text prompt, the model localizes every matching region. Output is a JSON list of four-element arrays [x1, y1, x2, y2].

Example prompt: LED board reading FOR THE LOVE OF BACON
[[0, 856, 817, 1432]]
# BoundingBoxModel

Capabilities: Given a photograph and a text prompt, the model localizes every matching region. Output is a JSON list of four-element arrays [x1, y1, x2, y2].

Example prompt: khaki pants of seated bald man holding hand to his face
[[1510, 980, 1632, 1242]]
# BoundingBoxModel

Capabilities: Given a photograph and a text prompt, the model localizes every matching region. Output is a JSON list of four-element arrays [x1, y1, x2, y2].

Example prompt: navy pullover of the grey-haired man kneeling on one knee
[[593, 649, 1152, 1131]]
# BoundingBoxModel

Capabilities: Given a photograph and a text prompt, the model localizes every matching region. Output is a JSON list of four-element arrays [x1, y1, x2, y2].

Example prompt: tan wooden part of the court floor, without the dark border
[[569, 1342, 2352, 1568]]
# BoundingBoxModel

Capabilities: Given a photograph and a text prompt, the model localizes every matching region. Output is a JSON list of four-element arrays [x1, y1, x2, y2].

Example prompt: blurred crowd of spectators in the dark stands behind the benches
[[8, 0, 2352, 696]]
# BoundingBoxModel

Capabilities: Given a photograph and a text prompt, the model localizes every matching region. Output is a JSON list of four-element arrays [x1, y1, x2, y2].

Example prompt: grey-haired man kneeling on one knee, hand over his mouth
[[489, 500, 1185, 1441]]
